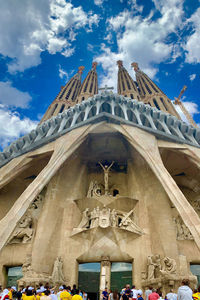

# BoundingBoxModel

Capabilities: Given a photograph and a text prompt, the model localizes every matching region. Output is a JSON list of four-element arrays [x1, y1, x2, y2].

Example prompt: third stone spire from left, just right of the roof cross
[[117, 60, 140, 100]]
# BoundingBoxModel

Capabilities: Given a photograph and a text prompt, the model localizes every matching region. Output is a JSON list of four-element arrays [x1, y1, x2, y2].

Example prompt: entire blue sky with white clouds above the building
[[0, 0, 200, 149]]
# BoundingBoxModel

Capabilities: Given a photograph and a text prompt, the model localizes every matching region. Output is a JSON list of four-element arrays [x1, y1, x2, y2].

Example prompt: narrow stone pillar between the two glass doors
[[99, 256, 111, 295]]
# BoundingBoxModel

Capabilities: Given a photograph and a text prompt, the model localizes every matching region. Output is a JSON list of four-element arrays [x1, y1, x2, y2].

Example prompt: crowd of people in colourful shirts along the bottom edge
[[0, 279, 200, 300]]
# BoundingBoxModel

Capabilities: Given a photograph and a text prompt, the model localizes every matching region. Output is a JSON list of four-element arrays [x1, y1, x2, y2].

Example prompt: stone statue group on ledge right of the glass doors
[[147, 254, 176, 280]]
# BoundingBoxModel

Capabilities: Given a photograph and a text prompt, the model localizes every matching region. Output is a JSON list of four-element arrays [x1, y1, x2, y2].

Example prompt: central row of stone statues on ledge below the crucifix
[[78, 206, 140, 232]]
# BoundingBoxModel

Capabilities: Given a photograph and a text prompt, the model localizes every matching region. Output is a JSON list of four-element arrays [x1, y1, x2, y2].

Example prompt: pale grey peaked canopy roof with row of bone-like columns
[[0, 91, 200, 167]]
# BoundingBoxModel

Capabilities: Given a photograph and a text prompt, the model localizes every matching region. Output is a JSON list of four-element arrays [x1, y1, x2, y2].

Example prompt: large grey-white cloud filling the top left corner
[[0, 0, 99, 73]]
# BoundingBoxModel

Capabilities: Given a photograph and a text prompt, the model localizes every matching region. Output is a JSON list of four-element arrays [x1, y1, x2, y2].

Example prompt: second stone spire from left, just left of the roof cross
[[78, 62, 98, 102]]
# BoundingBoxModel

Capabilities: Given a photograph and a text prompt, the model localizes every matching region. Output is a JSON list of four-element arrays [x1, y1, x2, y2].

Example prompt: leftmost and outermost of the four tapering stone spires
[[40, 66, 85, 124]]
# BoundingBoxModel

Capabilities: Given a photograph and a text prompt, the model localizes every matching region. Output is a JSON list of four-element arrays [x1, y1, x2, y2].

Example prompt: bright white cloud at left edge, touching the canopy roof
[[0, 105, 38, 148]]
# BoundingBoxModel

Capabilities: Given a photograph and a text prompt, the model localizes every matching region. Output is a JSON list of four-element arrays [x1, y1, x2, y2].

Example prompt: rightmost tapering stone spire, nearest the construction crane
[[131, 62, 180, 119]]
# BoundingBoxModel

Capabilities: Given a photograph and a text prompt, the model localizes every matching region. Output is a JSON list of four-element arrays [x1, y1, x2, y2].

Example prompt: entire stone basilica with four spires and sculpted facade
[[0, 61, 200, 299]]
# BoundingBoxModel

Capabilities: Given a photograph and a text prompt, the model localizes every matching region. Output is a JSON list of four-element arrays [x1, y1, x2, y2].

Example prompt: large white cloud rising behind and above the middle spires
[[95, 0, 183, 85]]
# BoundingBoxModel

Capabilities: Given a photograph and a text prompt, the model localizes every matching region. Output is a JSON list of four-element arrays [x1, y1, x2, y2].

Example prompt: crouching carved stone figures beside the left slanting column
[[9, 215, 33, 243]]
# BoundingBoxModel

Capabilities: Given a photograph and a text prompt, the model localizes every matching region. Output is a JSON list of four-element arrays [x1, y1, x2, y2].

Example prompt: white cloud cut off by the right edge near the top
[[183, 8, 200, 63]]
